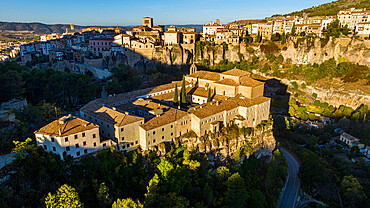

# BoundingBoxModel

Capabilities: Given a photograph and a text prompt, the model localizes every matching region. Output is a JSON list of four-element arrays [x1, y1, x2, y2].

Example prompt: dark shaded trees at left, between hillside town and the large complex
[[0, 62, 101, 109]]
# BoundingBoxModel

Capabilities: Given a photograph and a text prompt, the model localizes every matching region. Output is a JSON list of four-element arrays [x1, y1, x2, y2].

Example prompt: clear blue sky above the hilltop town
[[0, 0, 331, 26]]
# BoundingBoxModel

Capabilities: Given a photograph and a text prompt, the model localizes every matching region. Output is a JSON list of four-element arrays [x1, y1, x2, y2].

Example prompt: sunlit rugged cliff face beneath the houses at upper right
[[281, 38, 370, 66]]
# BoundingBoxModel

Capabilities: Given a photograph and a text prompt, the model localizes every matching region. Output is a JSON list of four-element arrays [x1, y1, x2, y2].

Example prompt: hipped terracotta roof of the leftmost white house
[[35, 116, 99, 137]]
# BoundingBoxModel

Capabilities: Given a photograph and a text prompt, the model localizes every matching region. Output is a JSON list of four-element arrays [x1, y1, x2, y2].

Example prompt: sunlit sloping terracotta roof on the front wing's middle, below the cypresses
[[141, 108, 187, 131]]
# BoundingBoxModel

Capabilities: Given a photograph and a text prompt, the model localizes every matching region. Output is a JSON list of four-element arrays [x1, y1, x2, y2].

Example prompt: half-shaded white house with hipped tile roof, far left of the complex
[[35, 115, 112, 158]]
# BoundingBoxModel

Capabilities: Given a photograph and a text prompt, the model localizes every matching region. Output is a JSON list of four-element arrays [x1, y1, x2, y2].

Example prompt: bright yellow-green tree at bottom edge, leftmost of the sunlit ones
[[45, 184, 83, 208]]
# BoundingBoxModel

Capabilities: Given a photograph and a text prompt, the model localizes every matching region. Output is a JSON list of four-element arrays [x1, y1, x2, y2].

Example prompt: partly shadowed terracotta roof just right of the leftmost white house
[[94, 106, 144, 126]]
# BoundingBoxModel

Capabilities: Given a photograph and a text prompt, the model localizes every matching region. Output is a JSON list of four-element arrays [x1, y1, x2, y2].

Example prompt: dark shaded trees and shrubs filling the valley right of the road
[[274, 116, 370, 207]]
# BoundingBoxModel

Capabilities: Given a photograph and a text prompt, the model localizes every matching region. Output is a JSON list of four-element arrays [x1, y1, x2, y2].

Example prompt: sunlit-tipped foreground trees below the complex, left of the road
[[0, 141, 287, 208]]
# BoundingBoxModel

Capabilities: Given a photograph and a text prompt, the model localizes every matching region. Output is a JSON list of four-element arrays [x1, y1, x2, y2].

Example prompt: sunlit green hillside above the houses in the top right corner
[[286, 0, 370, 17]]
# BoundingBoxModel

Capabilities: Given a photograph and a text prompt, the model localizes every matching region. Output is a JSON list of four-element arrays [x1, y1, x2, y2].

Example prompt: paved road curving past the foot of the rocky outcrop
[[277, 147, 299, 208]]
